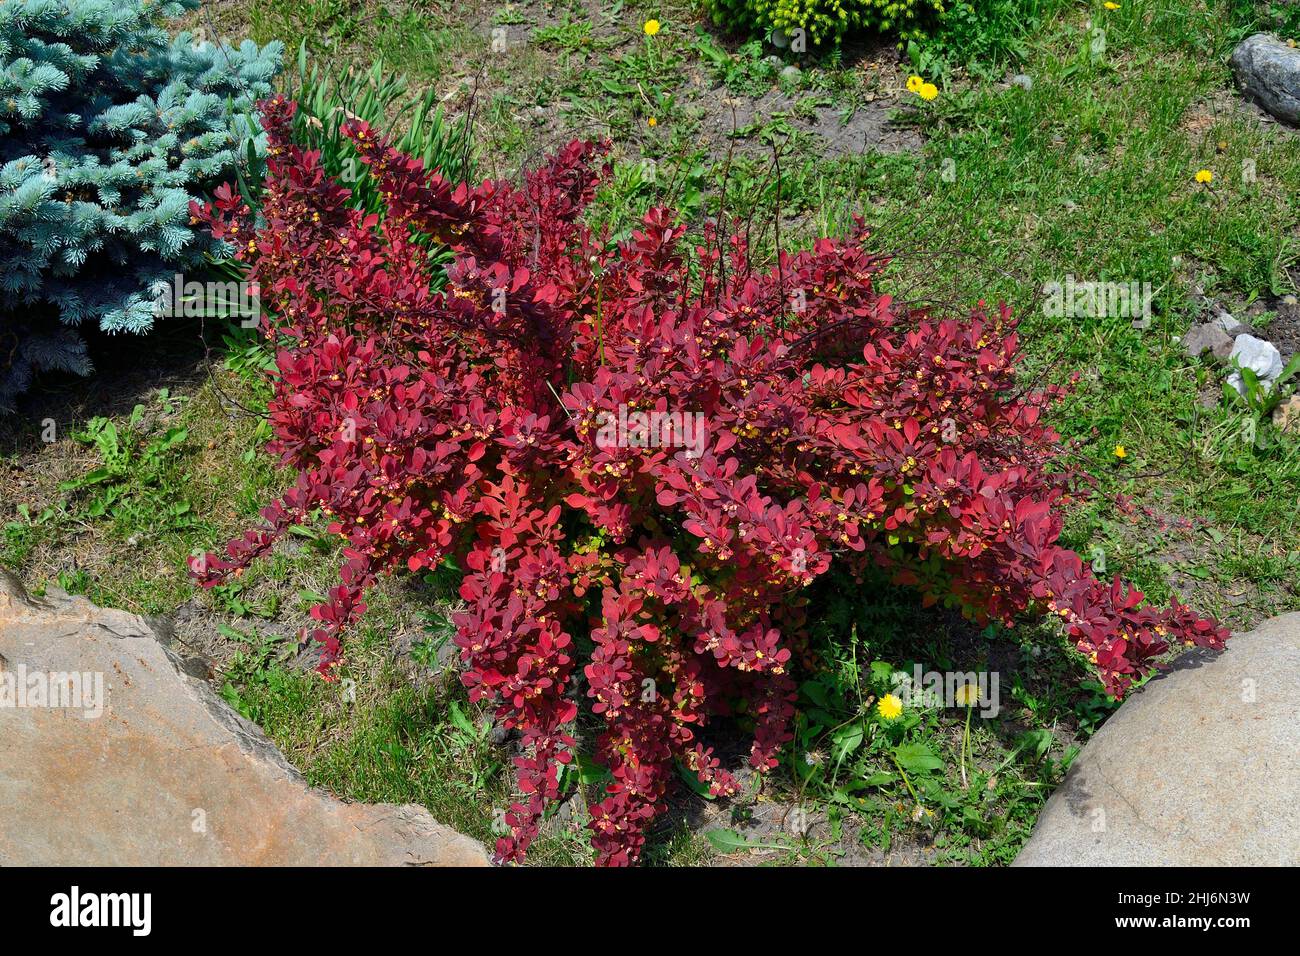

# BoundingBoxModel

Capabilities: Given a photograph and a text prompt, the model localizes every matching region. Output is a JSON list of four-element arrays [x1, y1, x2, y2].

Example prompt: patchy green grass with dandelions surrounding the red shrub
[[0, 0, 1300, 865]]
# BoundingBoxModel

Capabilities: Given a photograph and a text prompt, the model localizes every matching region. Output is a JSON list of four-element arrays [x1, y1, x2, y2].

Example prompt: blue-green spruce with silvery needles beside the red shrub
[[0, 0, 281, 408]]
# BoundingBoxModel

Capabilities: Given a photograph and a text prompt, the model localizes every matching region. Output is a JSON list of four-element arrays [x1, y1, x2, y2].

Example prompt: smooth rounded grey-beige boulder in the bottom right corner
[[1014, 614, 1300, 866]]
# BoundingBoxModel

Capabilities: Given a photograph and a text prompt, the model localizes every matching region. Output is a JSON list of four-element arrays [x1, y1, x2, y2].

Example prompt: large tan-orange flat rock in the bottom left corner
[[0, 568, 489, 866]]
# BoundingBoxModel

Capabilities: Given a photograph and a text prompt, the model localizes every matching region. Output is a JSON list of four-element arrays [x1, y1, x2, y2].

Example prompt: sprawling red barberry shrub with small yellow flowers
[[194, 99, 1227, 864]]
